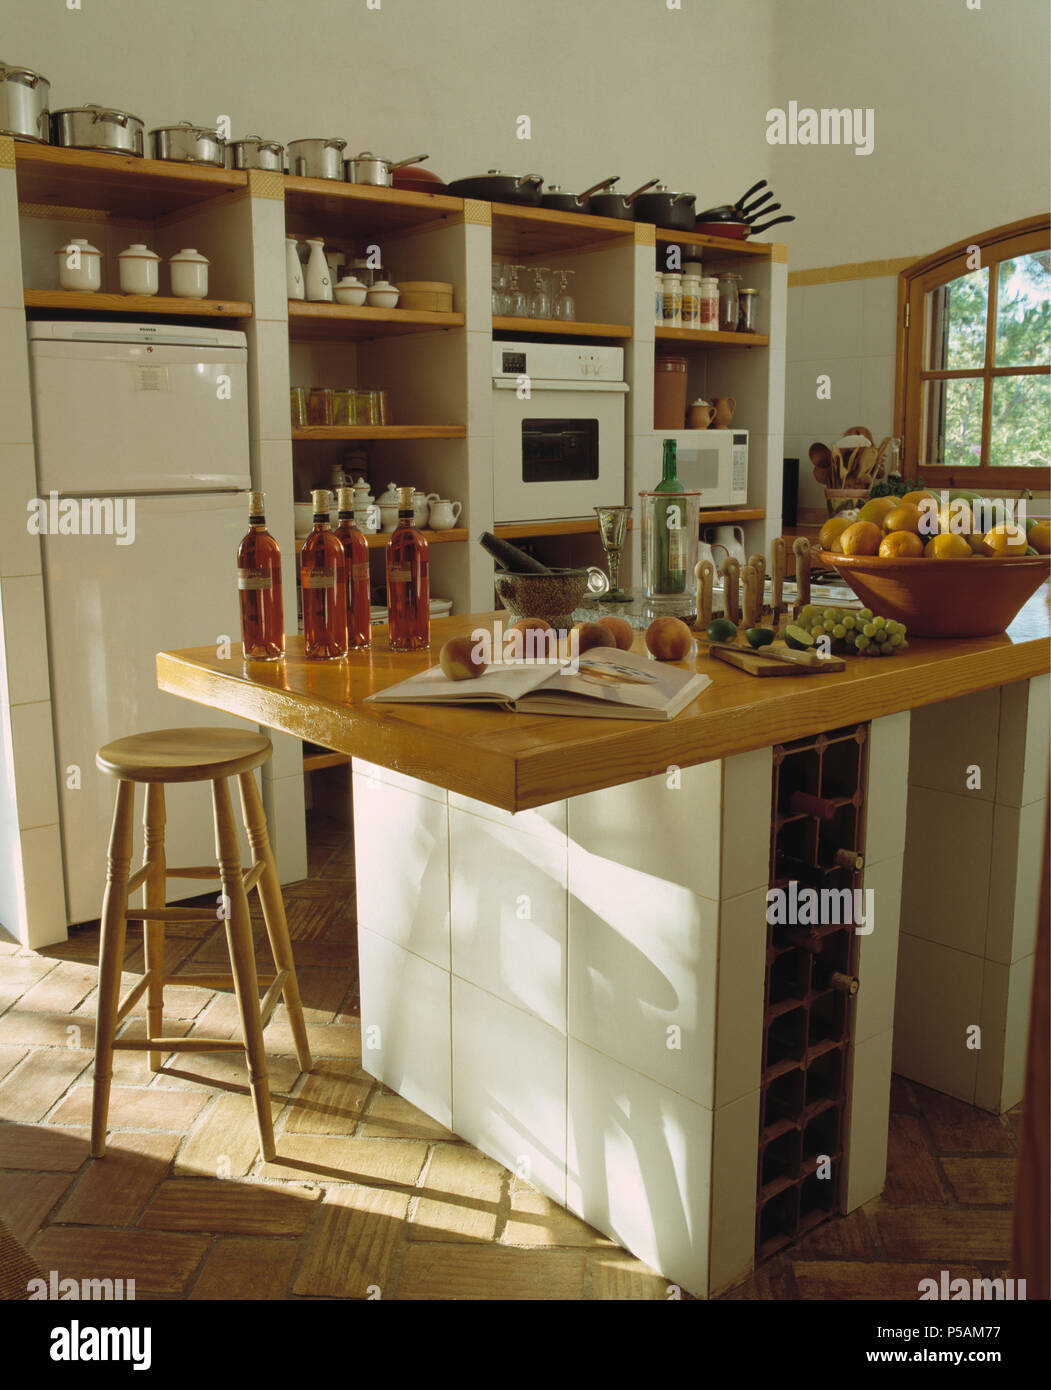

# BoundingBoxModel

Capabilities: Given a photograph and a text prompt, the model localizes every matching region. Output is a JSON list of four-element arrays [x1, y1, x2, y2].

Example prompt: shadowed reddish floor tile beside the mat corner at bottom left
[[31, 1226, 209, 1295]]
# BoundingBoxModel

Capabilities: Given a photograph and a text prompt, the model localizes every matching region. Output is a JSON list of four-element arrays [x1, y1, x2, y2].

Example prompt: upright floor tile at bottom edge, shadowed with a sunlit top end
[[292, 1184, 409, 1298]]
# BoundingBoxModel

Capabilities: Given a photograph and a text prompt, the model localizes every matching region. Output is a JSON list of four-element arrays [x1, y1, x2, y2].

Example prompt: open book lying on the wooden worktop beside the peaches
[[366, 646, 712, 719]]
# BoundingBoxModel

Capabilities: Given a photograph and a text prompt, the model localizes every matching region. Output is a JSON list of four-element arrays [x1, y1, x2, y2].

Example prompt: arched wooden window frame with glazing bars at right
[[894, 214, 1051, 492]]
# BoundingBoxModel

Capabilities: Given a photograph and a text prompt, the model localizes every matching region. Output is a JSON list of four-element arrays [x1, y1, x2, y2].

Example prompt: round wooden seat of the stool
[[95, 728, 274, 783]]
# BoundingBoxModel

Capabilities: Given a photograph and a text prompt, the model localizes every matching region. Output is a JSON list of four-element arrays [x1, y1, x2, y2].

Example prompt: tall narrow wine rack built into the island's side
[[755, 724, 869, 1261]]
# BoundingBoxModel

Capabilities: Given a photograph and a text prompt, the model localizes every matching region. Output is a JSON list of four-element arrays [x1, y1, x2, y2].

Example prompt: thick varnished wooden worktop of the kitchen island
[[157, 588, 1051, 810]]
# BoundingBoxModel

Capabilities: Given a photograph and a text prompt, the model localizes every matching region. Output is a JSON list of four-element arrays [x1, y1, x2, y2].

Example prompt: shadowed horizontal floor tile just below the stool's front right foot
[[139, 1177, 321, 1236]]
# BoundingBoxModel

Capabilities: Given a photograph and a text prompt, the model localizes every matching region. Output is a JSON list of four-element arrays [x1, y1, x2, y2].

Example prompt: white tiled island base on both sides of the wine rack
[[353, 713, 909, 1295]]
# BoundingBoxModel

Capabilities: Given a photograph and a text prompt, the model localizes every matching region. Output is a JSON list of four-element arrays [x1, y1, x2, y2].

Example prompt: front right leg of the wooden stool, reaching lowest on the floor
[[211, 778, 275, 1159]]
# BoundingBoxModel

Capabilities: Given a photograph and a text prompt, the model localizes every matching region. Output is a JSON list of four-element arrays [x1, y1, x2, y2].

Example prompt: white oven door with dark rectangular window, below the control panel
[[492, 378, 628, 524]]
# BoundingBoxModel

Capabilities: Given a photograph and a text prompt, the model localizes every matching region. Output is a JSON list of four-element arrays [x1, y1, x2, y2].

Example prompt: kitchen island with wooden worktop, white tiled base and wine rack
[[157, 591, 1051, 1295]]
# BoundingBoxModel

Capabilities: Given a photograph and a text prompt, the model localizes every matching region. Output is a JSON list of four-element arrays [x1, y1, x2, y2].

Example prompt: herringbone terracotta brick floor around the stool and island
[[0, 816, 1019, 1301]]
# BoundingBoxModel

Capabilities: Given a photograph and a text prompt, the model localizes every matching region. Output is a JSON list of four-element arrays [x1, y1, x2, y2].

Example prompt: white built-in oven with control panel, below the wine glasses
[[492, 342, 628, 524]]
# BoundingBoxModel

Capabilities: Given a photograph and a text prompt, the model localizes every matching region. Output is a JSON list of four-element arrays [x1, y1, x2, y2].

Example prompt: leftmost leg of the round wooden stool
[[92, 781, 135, 1158]]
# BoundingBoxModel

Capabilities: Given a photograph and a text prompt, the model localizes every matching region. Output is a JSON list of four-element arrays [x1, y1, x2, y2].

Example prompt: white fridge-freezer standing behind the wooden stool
[[29, 322, 257, 923]]
